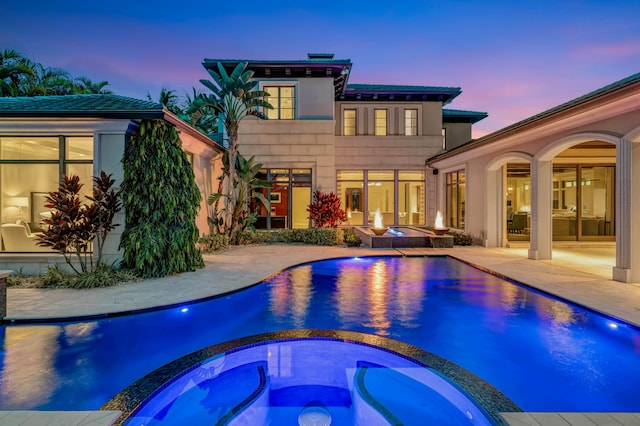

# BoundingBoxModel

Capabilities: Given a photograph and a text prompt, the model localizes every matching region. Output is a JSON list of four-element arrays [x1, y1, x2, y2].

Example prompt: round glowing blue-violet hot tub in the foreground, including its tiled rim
[[103, 330, 519, 425]]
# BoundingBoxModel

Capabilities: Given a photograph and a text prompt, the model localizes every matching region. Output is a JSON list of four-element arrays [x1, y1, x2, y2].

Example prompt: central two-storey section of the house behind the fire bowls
[[203, 53, 487, 228]]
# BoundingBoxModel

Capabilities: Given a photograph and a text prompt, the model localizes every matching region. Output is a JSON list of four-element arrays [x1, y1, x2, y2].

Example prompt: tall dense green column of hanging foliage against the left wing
[[120, 120, 204, 277]]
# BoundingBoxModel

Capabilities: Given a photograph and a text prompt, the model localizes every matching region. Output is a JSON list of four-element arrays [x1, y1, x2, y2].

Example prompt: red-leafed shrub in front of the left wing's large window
[[38, 172, 122, 273]]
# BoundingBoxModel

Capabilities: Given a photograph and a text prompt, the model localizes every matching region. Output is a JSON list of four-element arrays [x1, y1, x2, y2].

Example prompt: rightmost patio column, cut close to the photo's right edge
[[613, 139, 640, 283]]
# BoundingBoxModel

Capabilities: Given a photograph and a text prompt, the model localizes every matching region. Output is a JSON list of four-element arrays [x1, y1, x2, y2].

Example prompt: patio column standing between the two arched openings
[[529, 159, 553, 260]]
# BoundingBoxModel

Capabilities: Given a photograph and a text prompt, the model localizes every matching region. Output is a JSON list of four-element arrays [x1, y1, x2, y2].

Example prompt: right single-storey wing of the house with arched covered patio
[[426, 74, 640, 282]]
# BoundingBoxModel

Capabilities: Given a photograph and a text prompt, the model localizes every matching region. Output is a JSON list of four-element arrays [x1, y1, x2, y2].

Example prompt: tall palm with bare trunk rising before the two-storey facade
[[187, 62, 273, 241]]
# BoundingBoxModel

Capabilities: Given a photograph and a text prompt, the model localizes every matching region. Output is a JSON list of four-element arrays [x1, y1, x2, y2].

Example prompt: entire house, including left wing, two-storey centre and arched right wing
[[0, 53, 640, 282]]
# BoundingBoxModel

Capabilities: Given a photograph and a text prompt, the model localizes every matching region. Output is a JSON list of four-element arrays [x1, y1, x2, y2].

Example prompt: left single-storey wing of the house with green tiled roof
[[0, 95, 223, 273]]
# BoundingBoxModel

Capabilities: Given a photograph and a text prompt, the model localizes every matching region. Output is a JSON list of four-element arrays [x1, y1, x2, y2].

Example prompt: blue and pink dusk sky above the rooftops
[[0, 0, 640, 137]]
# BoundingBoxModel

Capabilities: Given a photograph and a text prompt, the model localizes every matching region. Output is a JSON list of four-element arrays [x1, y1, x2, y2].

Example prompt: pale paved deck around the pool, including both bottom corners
[[0, 245, 640, 426]]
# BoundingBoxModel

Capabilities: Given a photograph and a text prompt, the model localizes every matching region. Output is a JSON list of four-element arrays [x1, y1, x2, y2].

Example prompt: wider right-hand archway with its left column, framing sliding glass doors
[[529, 133, 620, 265]]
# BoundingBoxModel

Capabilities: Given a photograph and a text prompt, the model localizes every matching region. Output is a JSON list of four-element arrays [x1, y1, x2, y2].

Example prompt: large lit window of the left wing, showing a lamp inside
[[0, 136, 93, 252]]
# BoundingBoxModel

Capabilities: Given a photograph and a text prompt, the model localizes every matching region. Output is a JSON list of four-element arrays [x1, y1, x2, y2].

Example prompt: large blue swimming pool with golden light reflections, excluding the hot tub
[[0, 257, 640, 412]]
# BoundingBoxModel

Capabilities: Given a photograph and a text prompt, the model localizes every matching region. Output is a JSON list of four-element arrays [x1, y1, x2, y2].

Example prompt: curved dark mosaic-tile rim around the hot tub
[[100, 329, 522, 426]]
